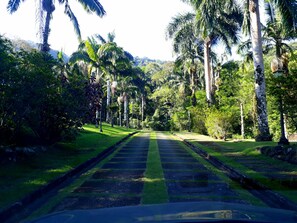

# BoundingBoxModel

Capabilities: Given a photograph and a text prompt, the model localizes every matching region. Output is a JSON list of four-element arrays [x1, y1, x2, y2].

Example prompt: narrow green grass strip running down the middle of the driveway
[[141, 132, 168, 204]]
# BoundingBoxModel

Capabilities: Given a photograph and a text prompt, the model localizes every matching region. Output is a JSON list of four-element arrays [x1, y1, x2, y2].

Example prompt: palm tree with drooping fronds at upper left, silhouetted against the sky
[[7, 0, 106, 52]]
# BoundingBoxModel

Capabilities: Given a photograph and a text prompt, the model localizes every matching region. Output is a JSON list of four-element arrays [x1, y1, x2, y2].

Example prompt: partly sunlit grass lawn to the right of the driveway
[[172, 133, 297, 202]]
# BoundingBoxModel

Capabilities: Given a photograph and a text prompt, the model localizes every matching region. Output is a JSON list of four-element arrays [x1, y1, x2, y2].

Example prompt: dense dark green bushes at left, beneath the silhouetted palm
[[0, 38, 88, 144]]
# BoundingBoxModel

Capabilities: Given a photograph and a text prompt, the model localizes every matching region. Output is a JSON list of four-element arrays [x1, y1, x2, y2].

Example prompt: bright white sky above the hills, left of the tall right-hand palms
[[0, 0, 191, 60]]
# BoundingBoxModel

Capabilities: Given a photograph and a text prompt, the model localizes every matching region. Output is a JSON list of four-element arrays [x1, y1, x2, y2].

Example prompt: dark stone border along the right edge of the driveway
[[172, 133, 297, 211]]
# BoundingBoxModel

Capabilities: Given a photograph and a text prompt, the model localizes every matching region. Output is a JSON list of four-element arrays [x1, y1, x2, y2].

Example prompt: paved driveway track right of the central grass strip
[[157, 133, 248, 204]]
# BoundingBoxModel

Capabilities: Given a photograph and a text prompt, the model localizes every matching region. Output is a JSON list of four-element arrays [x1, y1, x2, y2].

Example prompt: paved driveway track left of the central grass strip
[[52, 133, 149, 211]]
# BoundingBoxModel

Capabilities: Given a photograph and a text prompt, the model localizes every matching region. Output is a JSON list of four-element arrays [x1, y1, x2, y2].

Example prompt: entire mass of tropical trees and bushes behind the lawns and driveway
[[0, 0, 297, 144]]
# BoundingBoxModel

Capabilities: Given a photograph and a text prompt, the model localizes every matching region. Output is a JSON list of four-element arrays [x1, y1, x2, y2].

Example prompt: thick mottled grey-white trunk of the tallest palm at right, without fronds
[[249, 0, 272, 141]]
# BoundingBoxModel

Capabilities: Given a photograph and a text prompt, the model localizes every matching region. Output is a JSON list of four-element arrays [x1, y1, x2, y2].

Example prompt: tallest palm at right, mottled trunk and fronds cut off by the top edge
[[240, 0, 297, 141]]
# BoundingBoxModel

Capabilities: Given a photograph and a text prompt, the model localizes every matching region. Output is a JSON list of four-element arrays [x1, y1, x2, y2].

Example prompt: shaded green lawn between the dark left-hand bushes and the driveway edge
[[0, 124, 134, 209]]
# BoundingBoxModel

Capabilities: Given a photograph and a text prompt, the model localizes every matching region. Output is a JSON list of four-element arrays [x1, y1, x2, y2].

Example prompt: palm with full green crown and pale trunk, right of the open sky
[[183, 0, 242, 104]]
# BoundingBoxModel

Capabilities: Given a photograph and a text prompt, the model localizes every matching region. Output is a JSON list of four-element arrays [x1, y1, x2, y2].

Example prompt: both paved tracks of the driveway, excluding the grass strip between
[[51, 132, 254, 212]]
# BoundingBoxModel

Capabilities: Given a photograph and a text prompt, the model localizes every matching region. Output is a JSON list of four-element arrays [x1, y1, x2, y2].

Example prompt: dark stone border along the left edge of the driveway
[[0, 131, 139, 222]]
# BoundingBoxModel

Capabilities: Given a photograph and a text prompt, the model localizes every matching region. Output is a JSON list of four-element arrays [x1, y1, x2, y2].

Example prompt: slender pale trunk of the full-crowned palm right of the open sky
[[204, 38, 214, 105]]
